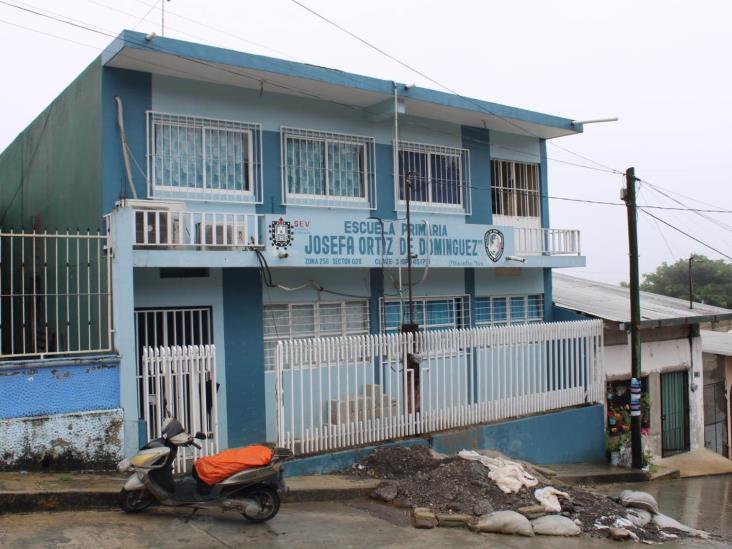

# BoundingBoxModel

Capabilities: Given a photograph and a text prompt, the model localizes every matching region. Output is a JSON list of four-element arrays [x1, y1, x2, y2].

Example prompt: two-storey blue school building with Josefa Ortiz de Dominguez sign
[[0, 31, 608, 466]]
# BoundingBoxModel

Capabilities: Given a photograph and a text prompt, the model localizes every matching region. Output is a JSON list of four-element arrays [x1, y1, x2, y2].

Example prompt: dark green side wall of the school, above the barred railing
[[0, 58, 102, 231]]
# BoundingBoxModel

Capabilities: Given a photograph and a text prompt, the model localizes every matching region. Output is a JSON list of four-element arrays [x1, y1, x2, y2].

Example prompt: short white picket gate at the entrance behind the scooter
[[138, 345, 219, 472]]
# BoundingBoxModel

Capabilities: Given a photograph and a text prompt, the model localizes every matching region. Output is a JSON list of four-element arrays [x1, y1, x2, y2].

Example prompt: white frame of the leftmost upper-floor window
[[146, 111, 262, 202]]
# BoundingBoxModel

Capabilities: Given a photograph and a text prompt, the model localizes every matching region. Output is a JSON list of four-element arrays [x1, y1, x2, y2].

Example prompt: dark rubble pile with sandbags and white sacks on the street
[[352, 446, 706, 543]]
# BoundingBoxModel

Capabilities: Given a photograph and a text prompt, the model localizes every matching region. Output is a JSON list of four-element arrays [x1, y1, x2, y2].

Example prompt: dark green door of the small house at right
[[661, 370, 689, 457]]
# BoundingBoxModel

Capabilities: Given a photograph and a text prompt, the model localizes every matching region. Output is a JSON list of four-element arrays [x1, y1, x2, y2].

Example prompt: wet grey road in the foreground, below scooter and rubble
[[0, 476, 732, 549]]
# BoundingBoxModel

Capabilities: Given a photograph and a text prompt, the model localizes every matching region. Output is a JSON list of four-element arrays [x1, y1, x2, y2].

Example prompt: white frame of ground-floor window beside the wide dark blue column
[[262, 299, 371, 370]]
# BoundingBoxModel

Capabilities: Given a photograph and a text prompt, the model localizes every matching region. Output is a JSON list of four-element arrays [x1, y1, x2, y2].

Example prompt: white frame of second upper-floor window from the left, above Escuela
[[280, 126, 376, 208]]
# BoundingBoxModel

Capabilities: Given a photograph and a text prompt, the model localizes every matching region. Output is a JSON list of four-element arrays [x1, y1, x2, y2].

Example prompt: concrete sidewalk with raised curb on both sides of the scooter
[[0, 472, 380, 514]]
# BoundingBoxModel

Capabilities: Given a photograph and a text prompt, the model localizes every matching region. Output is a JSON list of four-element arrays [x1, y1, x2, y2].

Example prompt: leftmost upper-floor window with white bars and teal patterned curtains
[[147, 111, 261, 202]]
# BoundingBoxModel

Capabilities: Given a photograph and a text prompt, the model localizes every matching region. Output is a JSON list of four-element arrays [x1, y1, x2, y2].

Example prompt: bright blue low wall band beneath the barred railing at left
[[0, 359, 119, 418]]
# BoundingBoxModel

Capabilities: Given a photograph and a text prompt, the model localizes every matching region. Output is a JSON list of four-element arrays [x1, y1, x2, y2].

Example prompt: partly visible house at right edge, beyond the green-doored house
[[701, 330, 732, 459]]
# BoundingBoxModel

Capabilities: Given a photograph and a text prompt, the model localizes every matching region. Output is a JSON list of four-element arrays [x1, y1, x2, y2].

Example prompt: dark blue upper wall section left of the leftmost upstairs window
[[102, 67, 152, 213]]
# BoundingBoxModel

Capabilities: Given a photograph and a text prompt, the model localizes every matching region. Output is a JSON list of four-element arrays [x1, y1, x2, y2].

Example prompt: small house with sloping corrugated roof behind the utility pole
[[553, 273, 732, 456]]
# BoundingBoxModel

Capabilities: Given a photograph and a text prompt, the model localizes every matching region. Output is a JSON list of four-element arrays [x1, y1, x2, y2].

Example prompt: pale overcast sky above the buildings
[[0, 0, 732, 283]]
